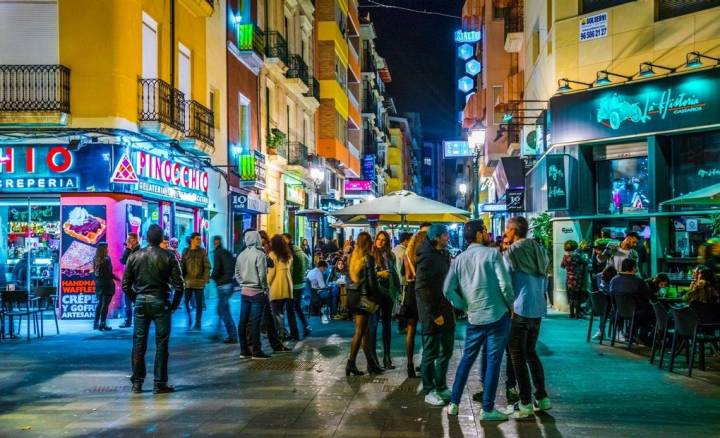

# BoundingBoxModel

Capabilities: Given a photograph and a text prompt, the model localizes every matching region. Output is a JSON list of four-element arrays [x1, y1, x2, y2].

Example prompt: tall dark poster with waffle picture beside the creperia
[[60, 205, 107, 319]]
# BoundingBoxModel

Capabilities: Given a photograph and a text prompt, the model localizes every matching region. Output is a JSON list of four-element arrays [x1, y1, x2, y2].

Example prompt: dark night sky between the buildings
[[360, 0, 464, 140]]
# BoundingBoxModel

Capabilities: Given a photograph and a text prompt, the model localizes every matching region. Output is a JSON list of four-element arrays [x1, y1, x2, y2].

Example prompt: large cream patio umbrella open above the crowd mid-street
[[328, 190, 470, 228]]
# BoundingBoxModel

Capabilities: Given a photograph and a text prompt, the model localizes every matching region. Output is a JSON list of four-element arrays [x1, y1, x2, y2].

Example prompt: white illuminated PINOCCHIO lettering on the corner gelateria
[[136, 151, 208, 192]]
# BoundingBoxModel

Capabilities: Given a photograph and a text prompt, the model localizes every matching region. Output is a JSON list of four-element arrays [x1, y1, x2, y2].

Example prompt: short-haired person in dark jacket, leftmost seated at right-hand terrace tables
[[610, 258, 655, 345]]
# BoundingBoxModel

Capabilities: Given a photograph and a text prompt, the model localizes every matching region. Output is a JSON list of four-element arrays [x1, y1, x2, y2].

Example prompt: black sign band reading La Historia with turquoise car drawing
[[550, 68, 720, 144]]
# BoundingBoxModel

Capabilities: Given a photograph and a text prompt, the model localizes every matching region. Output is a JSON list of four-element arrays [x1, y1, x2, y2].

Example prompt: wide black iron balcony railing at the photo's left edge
[[0, 65, 70, 114]]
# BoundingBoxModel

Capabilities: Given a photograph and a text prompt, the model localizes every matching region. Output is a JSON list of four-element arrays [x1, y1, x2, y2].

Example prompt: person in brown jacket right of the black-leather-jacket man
[[182, 233, 210, 330]]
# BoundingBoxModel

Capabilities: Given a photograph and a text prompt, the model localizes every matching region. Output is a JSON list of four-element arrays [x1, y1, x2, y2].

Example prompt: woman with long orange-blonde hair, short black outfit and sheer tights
[[345, 231, 382, 376]]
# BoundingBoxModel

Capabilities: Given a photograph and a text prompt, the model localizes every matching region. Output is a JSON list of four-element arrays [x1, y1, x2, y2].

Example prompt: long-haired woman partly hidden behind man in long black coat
[[401, 231, 427, 379]]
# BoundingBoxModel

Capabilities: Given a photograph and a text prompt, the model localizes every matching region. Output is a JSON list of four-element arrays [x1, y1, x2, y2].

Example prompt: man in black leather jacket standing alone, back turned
[[122, 224, 185, 394]]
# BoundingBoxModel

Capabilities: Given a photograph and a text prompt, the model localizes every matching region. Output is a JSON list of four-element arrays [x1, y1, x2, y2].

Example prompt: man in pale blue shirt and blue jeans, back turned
[[445, 220, 514, 421]]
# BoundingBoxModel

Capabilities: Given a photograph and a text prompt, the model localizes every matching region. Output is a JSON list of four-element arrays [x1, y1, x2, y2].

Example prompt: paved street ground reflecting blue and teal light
[[0, 297, 720, 438]]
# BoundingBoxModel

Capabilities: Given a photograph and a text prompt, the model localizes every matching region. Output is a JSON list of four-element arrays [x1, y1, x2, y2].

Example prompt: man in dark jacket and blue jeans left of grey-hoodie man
[[210, 236, 238, 344]]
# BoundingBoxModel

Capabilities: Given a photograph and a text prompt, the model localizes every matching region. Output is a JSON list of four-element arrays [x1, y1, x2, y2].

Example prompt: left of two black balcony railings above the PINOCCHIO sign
[[138, 79, 185, 132]]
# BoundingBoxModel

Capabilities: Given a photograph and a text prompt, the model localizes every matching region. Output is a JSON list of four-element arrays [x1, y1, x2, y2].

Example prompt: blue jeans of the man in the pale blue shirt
[[450, 314, 510, 412]]
